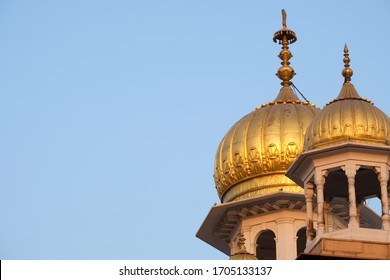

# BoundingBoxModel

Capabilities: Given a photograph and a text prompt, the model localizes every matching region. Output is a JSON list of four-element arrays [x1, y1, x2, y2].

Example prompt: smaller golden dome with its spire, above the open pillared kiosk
[[304, 46, 390, 151]]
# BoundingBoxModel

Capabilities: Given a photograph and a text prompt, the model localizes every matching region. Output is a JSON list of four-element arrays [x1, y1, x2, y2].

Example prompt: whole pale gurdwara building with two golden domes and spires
[[197, 10, 390, 260]]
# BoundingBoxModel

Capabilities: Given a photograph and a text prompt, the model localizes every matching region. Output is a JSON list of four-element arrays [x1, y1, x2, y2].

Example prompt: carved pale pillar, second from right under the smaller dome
[[344, 163, 359, 228]]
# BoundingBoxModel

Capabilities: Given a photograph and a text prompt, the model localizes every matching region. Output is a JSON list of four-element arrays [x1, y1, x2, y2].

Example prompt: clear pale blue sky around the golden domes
[[0, 0, 390, 259]]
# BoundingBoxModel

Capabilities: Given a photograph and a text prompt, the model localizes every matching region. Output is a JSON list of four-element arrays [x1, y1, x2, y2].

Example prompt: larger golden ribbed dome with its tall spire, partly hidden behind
[[214, 10, 319, 203]]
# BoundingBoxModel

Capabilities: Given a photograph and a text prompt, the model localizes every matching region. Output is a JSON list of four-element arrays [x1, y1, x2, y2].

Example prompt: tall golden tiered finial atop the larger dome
[[274, 9, 297, 87]]
